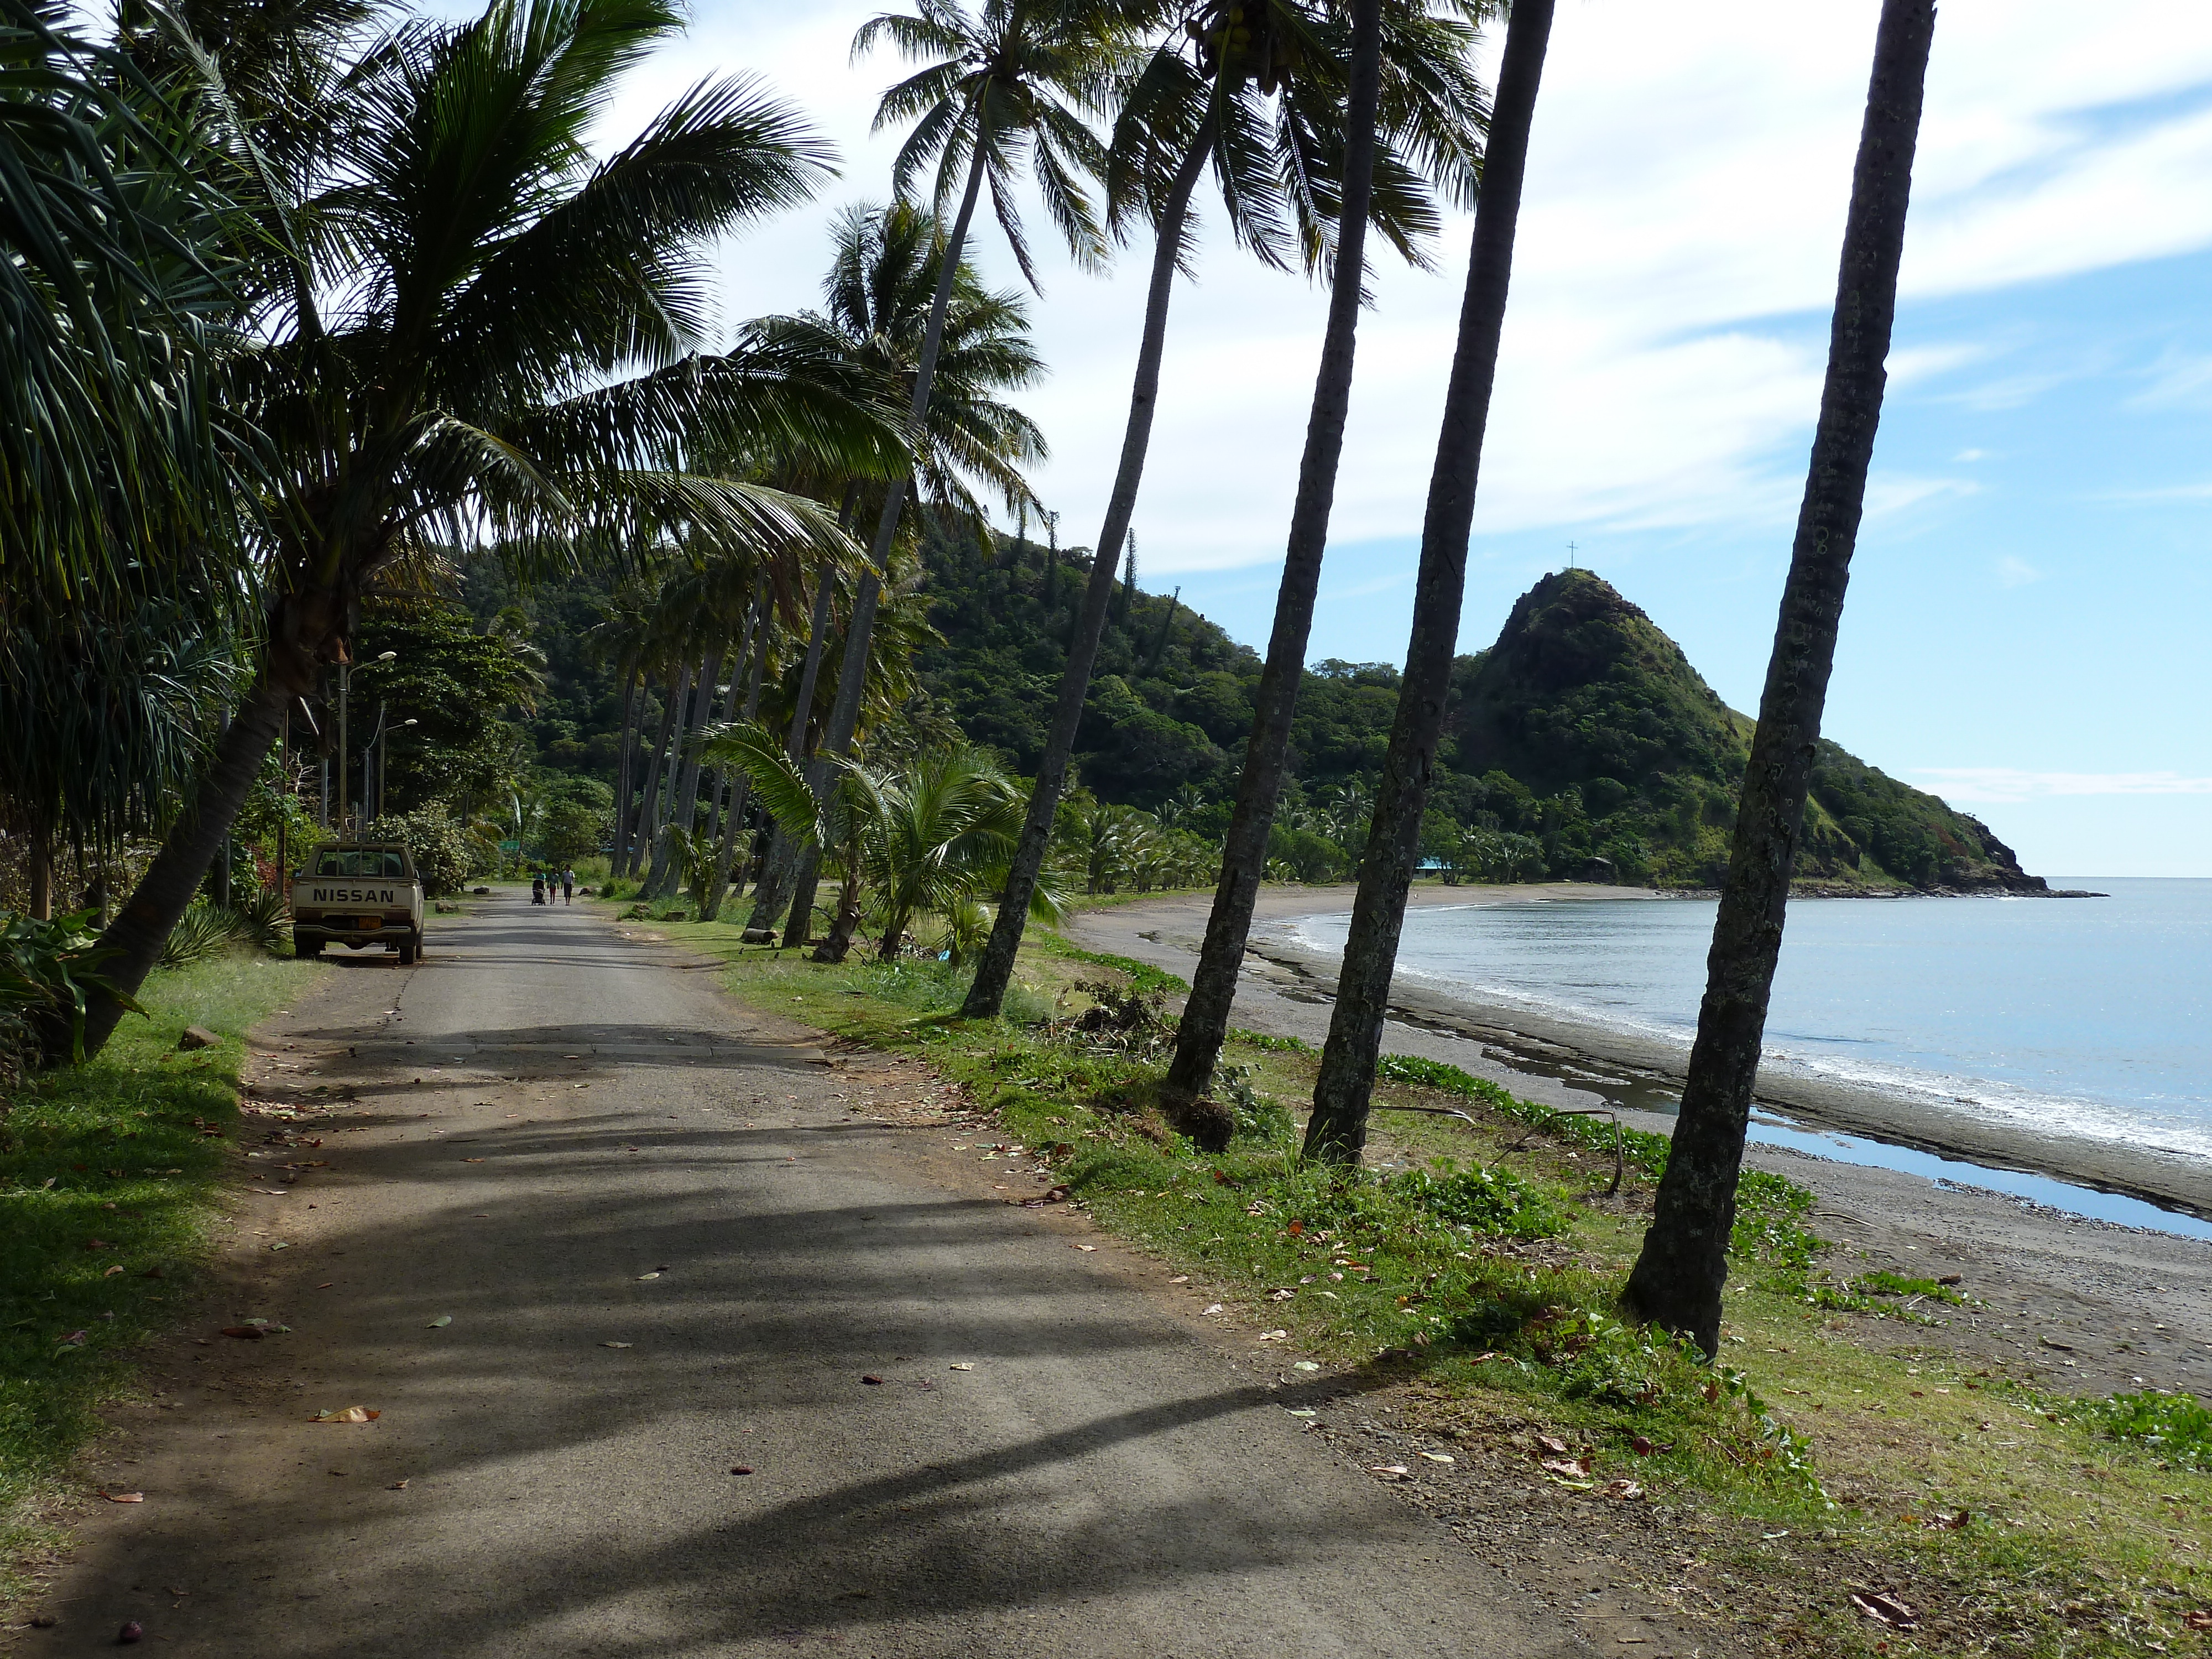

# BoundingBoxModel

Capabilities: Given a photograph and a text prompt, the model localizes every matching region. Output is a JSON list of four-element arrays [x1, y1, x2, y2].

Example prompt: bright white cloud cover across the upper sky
[[606, 0, 2212, 577]]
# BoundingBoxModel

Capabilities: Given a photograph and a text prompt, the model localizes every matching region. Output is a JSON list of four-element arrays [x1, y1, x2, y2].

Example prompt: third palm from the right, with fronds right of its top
[[1161, 0, 1486, 1141]]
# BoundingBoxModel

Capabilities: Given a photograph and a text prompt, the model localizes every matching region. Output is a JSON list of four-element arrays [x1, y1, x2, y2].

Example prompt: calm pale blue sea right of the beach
[[1301, 878, 2212, 1159]]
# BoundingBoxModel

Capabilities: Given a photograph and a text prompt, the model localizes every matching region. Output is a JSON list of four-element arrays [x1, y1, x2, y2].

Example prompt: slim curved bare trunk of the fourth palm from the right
[[960, 117, 1214, 1020]]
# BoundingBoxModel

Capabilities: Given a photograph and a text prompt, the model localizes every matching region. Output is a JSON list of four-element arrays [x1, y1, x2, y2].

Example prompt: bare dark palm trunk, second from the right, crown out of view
[[1305, 0, 1553, 1164]]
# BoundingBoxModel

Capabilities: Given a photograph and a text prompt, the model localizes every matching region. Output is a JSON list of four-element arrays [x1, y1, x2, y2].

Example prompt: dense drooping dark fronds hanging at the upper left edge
[[0, 0, 252, 918]]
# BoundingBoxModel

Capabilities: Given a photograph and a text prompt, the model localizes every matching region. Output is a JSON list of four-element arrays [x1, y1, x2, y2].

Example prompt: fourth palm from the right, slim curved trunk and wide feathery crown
[[962, 0, 1482, 1018]]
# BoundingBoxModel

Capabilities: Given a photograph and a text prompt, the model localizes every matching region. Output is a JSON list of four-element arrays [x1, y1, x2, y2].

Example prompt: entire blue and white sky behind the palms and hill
[[606, 0, 2212, 878]]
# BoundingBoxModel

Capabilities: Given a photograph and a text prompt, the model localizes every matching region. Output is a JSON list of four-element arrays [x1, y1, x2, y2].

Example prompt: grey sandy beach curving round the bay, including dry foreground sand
[[1068, 883, 2212, 1396]]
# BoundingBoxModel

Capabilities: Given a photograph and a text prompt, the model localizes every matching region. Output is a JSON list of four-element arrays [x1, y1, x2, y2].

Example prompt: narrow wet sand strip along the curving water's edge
[[1062, 883, 2212, 1221]]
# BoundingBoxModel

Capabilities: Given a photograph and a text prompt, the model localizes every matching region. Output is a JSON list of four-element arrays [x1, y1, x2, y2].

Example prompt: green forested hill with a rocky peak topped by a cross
[[920, 535, 2044, 891]]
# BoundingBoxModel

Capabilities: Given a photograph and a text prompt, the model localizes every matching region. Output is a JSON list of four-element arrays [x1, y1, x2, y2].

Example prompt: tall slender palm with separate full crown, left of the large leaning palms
[[787, 0, 1130, 938]]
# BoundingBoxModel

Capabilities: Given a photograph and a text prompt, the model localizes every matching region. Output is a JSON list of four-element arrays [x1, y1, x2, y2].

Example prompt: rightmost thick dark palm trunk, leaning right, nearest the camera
[[1628, 0, 1936, 1354]]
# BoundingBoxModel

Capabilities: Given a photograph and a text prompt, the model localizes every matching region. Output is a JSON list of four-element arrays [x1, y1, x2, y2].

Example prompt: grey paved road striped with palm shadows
[[43, 898, 1593, 1659]]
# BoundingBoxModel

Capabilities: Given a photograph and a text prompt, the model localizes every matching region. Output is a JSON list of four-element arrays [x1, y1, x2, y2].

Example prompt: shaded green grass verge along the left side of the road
[[0, 951, 325, 1593]]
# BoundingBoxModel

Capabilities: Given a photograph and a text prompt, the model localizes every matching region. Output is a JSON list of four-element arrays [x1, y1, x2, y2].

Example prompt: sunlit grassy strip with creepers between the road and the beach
[[597, 898, 2212, 1655]]
